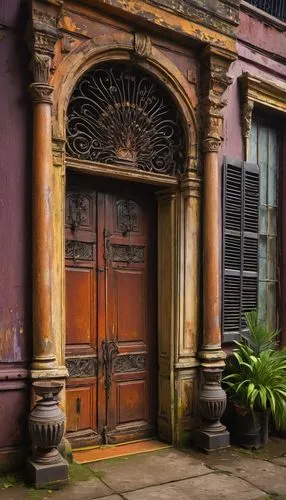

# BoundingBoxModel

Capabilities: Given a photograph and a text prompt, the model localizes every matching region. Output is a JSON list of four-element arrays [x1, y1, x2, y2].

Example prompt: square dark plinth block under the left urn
[[27, 457, 69, 489]]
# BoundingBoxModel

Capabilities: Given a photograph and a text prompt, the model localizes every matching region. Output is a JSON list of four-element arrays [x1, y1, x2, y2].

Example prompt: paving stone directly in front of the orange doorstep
[[89, 449, 211, 493]]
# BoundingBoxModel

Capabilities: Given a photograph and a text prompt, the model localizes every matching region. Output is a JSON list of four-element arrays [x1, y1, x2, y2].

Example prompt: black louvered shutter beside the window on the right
[[222, 158, 259, 342]]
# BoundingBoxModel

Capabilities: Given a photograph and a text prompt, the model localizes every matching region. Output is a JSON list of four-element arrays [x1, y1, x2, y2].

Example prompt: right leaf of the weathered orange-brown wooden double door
[[98, 188, 157, 443]]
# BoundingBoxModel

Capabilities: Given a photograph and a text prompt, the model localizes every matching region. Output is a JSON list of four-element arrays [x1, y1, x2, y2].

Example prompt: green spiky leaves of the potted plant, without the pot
[[223, 311, 286, 429]]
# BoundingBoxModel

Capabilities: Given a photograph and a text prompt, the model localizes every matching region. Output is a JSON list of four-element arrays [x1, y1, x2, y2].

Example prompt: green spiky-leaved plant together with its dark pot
[[223, 311, 286, 448]]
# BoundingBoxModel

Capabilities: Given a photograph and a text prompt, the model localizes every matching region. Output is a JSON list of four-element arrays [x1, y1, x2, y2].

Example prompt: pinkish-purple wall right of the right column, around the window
[[223, 7, 286, 345]]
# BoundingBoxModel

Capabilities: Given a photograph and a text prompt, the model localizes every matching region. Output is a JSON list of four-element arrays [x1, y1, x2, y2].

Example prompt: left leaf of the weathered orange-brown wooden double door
[[65, 187, 101, 446]]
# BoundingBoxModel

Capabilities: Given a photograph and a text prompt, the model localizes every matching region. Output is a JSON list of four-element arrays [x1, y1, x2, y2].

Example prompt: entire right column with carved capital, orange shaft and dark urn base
[[195, 47, 235, 451]]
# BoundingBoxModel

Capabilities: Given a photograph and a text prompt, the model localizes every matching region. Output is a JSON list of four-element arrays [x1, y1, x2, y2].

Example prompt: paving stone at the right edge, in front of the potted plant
[[209, 457, 286, 495]]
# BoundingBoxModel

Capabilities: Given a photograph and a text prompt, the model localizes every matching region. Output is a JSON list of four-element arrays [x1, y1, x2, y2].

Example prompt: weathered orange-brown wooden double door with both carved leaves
[[65, 176, 157, 447]]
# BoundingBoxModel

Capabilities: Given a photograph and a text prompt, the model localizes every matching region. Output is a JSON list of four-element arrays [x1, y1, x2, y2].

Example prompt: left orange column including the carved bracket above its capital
[[28, 0, 66, 379]]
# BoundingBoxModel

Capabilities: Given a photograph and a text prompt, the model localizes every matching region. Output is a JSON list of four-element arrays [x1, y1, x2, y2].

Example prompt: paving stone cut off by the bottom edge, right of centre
[[123, 474, 266, 500]]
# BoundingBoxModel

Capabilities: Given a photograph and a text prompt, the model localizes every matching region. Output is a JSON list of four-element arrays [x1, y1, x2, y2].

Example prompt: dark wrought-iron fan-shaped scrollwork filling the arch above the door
[[67, 63, 186, 176]]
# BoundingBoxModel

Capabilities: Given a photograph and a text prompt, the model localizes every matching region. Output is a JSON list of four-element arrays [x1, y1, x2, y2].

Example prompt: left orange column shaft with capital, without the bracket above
[[30, 52, 57, 370]]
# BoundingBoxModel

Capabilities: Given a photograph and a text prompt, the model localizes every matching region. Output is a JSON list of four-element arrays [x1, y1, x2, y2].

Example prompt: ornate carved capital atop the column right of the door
[[202, 46, 235, 152]]
